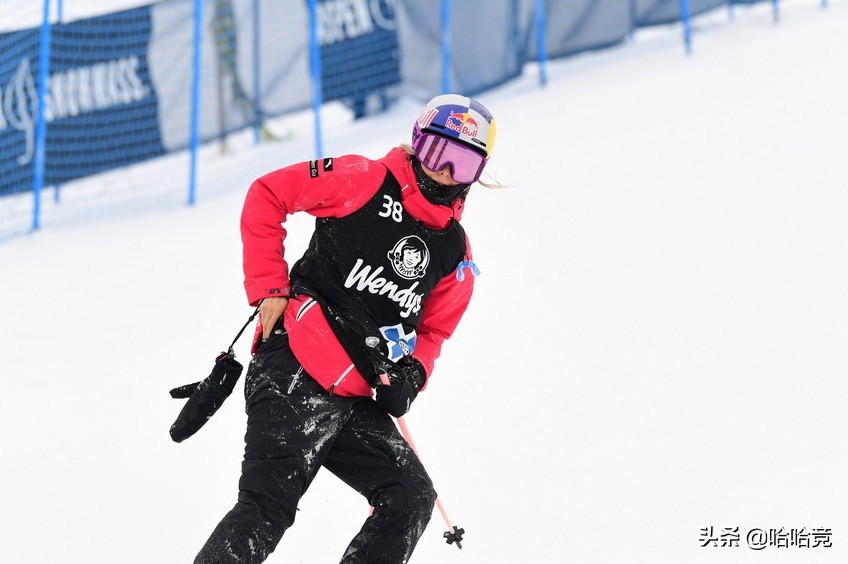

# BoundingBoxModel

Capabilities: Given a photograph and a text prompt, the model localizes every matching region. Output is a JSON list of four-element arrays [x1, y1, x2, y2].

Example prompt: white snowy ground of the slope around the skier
[[0, 0, 848, 564]]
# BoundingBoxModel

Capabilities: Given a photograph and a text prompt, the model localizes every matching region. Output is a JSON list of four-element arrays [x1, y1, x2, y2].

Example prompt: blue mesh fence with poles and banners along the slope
[[0, 0, 827, 240]]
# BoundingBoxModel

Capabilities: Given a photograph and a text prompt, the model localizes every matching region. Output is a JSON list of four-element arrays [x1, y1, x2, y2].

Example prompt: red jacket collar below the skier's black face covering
[[379, 147, 465, 229]]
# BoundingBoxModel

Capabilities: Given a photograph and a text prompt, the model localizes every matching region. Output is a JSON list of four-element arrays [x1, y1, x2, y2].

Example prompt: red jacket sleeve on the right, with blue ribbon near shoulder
[[412, 234, 474, 389]]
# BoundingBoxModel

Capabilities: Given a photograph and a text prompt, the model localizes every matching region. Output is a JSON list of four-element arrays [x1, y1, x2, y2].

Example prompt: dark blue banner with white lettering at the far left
[[0, 7, 164, 195]]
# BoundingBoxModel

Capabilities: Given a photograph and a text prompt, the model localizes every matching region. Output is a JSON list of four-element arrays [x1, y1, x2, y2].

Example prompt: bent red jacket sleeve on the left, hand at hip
[[241, 155, 386, 306]]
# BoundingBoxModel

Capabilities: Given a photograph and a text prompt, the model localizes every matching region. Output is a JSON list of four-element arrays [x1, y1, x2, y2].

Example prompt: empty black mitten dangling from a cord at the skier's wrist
[[171, 353, 243, 443]]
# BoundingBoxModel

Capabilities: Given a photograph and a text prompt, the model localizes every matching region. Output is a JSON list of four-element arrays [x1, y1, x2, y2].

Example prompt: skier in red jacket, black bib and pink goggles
[[195, 94, 495, 564]]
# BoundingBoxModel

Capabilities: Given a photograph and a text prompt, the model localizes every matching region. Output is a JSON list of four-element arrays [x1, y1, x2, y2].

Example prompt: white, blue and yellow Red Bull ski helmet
[[412, 94, 495, 159]]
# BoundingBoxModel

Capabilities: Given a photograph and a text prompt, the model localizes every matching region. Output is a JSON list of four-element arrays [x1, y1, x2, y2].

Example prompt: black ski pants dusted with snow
[[195, 333, 436, 564]]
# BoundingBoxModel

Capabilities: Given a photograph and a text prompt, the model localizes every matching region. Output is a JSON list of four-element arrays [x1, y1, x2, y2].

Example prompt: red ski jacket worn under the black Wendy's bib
[[241, 147, 474, 396]]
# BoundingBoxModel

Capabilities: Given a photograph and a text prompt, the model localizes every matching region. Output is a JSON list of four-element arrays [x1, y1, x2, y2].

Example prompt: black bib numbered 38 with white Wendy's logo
[[291, 166, 466, 379]]
